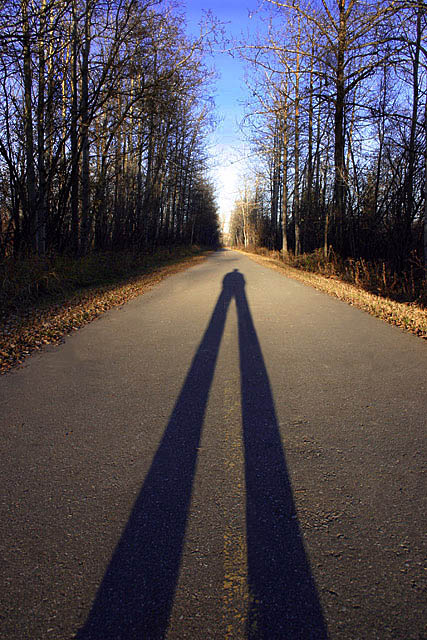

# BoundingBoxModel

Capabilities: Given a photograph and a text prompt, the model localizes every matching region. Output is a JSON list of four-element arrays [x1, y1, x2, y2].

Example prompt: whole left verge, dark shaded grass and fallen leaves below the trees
[[0, 246, 211, 374]]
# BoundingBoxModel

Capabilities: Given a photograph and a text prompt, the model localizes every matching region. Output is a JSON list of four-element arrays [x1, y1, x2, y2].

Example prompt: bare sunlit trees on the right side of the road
[[230, 0, 427, 270]]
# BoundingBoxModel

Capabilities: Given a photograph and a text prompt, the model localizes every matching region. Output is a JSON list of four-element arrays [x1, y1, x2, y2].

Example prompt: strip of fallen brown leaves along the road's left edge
[[0, 252, 206, 374]]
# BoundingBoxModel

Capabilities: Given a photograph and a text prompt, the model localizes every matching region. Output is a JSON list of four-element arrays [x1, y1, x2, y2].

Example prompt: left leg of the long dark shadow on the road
[[77, 292, 230, 640]]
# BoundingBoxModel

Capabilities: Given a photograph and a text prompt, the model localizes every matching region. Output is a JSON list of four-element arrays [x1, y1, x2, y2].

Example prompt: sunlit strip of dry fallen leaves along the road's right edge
[[239, 249, 427, 339]]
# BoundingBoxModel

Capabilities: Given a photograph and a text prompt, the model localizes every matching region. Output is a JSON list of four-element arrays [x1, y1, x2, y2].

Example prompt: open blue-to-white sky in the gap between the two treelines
[[181, 0, 259, 224]]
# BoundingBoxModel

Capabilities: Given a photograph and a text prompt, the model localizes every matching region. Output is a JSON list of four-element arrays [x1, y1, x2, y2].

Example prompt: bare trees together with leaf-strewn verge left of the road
[[0, 0, 219, 371]]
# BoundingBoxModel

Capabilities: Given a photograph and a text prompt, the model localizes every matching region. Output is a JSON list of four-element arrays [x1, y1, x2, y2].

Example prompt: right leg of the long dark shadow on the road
[[232, 273, 327, 640]]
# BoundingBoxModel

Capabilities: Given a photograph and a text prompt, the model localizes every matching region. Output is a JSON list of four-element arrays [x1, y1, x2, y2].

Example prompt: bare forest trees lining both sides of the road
[[0, 0, 427, 310]]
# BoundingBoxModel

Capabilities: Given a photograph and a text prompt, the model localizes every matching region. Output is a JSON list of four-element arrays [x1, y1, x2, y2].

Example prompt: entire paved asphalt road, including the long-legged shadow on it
[[0, 251, 427, 640]]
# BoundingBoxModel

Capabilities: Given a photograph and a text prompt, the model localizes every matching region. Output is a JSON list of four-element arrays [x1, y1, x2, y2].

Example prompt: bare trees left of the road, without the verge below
[[0, 0, 218, 259]]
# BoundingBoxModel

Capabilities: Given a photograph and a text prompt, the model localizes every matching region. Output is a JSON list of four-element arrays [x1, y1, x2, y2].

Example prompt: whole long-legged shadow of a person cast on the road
[[77, 269, 327, 640]]
